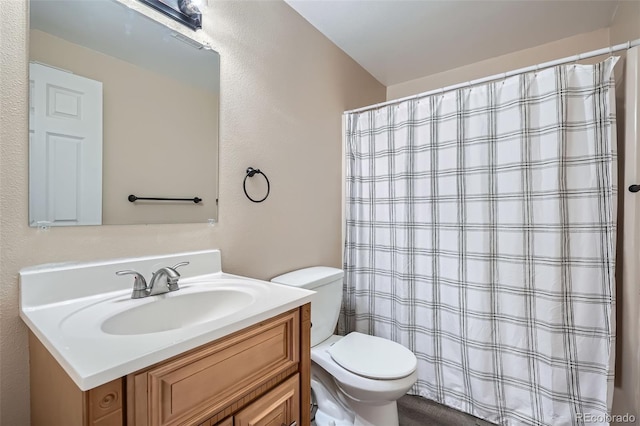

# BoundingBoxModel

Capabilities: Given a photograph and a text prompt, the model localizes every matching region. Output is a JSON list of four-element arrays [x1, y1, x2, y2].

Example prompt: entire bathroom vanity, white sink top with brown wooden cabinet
[[20, 250, 313, 426]]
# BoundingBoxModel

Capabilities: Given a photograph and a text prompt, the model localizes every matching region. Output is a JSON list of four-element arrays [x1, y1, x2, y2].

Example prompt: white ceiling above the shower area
[[285, 0, 619, 86]]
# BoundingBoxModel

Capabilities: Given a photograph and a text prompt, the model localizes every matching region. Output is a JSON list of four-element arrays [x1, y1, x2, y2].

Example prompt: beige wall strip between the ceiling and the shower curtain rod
[[387, 28, 609, 100]]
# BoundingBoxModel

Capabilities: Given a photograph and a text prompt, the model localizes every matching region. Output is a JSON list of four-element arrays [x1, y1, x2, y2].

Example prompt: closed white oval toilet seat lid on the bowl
[[327, 332, 417, 380]]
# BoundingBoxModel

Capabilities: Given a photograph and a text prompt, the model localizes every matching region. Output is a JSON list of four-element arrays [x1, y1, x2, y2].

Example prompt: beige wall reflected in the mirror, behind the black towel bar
[[29, 30, 218, 225]]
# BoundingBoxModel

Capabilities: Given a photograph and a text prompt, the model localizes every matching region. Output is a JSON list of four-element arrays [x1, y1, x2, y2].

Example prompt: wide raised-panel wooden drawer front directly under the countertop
[[131, 310, 300, 426]]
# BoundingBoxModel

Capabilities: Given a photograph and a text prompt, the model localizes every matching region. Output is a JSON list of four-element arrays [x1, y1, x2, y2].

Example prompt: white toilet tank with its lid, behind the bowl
[[271, 266, 344, 346]]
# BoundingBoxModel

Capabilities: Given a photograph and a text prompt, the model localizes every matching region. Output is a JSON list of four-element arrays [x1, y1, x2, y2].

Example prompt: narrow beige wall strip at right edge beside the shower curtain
[[610, 1, 640, 418]]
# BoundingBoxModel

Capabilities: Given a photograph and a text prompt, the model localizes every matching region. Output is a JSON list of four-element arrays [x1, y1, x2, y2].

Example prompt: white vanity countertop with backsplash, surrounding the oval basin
[[20, 250, 314, 390]]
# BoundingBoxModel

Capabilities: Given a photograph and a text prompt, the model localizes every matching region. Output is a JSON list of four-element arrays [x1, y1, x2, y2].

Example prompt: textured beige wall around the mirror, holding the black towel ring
[[0, 0, 385, 426]]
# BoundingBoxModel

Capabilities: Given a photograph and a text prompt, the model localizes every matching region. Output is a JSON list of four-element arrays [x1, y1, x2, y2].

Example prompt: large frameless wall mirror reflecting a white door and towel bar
[[29, 0, 220, 226]]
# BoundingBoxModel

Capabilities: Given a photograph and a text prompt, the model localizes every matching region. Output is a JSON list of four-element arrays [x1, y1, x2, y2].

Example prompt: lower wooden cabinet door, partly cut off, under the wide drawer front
[[233, 374, 300, 426]]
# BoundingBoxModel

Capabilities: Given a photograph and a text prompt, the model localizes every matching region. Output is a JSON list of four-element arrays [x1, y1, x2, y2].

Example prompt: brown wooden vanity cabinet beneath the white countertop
[[29, 304, 311, 426]]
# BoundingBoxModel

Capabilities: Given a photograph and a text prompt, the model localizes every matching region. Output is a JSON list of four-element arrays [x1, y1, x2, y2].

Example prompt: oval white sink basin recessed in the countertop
[[100, 289, 255, 335]]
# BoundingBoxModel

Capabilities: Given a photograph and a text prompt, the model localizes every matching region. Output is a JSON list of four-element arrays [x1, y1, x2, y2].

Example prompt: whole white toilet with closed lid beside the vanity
[[271, 266, 417, 426]]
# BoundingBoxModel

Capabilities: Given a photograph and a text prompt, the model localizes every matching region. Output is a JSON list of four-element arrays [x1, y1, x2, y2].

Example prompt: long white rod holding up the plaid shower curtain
[[342, 38, 640, 115]]
